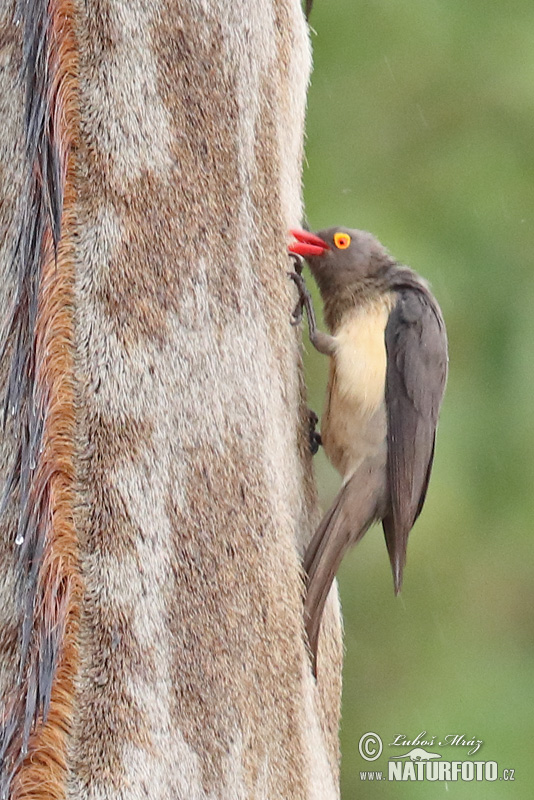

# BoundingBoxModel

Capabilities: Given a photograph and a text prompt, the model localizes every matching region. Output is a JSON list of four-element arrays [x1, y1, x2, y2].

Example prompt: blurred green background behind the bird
[[304, 0, 534, 800]]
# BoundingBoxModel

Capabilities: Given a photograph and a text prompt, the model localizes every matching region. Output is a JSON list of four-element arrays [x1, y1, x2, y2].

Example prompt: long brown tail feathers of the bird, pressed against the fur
[[304, 468, 383, 675]]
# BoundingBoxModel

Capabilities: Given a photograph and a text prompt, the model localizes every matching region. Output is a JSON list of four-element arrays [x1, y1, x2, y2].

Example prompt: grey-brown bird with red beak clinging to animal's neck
[[289, 227, 448, 674]]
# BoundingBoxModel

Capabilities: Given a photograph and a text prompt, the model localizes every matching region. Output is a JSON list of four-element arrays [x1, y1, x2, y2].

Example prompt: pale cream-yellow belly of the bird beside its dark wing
[[321, 298, 390, 480]]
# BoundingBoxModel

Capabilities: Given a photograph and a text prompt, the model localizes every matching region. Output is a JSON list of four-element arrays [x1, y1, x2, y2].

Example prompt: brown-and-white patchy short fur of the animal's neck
[[0, 0, 341, 800]]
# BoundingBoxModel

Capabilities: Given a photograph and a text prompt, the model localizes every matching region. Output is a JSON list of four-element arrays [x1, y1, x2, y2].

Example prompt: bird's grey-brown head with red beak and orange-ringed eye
[[289, 228, 394, 294]]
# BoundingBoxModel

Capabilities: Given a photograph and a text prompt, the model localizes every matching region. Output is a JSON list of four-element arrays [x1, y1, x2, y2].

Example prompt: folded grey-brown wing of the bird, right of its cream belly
[[383, 282, 447, 591]]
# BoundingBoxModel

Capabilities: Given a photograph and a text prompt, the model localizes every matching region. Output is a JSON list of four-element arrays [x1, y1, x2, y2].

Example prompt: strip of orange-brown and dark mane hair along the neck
[[0, 0, 79, 800]]
